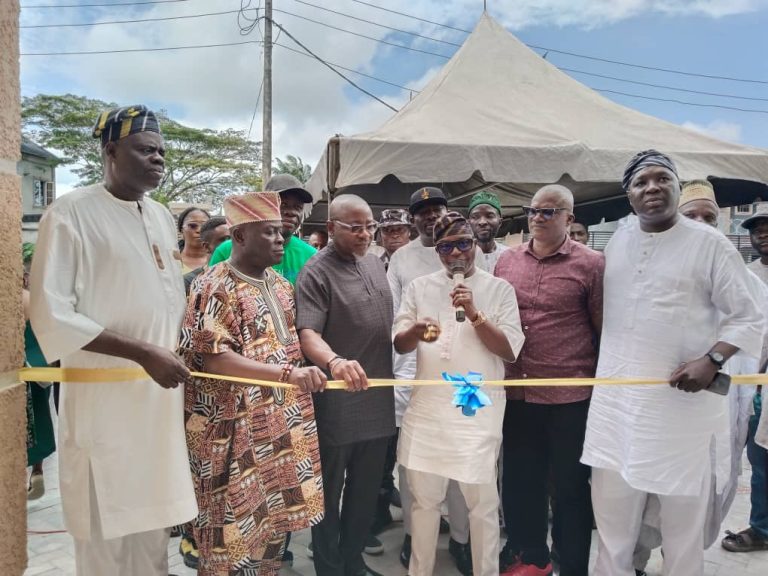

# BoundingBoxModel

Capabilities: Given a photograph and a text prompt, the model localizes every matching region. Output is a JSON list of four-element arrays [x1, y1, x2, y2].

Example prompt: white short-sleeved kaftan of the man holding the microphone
[[392, 269, 524, 484]]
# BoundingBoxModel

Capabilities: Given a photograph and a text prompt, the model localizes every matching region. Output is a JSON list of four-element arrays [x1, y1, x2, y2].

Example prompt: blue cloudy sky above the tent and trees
[[16, 0, 768, 192]]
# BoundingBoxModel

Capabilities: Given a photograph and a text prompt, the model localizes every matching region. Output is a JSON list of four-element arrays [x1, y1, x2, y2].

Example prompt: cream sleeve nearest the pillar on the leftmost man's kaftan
[[29, 205, 104, 363]]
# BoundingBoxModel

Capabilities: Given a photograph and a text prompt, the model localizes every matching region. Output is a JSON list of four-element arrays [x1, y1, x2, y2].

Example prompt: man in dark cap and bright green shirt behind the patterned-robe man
[[210, 174, 317, 285]]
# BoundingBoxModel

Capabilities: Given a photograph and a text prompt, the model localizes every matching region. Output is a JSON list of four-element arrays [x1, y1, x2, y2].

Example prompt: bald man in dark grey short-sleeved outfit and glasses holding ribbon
[[296, 194, 395, 576]]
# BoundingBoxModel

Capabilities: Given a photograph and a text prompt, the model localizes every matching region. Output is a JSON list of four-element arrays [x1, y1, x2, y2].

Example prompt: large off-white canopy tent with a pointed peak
[[308, 13, 768, 223]]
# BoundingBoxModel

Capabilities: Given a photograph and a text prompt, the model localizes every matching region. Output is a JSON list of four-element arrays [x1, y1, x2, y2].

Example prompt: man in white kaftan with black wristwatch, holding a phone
[[582, 150, 763, 576]]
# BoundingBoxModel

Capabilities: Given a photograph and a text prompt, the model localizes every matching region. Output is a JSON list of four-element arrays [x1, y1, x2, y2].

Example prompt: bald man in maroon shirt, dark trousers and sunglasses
[[495, 185, 604, 576]]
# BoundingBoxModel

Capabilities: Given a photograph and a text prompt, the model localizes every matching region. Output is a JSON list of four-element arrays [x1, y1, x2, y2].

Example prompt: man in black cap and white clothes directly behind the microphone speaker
[[387, 186, 483, 575]]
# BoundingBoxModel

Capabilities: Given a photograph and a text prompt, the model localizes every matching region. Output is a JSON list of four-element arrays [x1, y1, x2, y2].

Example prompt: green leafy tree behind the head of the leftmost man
[[22, 94, 261, 205]]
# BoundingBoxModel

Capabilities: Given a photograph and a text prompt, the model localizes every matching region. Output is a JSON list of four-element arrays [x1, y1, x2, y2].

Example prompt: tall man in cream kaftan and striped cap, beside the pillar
[[31, 106, 197, 576]]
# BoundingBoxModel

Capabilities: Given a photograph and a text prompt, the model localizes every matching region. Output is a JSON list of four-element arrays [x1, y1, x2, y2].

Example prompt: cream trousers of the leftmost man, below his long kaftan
[[75, 470, 170, 576]]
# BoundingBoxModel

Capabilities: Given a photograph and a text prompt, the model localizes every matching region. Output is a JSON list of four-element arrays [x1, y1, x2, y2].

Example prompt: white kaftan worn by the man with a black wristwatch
[[582, 216, 763, 496]]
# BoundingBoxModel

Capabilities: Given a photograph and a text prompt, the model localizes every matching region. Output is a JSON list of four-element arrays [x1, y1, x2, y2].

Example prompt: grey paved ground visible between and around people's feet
[[25, 418, 768, 576]]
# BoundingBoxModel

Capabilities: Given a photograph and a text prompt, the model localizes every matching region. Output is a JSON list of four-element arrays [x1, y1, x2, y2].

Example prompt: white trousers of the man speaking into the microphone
[[406, 470, 499, 576]]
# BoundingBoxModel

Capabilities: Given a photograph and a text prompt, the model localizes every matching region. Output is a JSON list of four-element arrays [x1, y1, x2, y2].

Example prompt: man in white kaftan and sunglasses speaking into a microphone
[[392, 212, 524, 576]]
